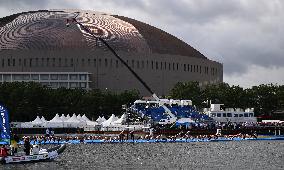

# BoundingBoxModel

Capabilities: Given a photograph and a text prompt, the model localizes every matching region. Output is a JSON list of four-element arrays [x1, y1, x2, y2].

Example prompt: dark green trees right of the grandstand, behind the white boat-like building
[[170, 82, 284, 115]]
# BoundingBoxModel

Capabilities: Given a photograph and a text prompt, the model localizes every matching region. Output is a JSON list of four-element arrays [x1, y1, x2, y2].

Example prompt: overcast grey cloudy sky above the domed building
[[0, 0, 284, 87]]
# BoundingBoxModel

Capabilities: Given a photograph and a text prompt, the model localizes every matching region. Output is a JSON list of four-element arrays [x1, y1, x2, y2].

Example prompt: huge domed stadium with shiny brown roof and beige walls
[[0, 10, 223, 95]]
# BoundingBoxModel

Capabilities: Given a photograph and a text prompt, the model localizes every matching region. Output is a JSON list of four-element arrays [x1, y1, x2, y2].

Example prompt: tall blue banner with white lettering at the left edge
[[0, 105, 10, 143]]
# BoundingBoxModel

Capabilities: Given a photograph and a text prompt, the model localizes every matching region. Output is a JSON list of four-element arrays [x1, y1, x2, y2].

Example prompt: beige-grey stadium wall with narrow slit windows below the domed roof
[[0, 48, 223, 95]]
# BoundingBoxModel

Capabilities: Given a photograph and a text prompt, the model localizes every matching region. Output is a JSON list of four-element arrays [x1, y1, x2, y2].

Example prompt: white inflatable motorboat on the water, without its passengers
[[0, 144, 66, 164]]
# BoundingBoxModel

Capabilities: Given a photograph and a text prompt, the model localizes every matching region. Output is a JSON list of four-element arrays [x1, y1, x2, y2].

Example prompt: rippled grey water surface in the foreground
[[0, 141, 284, 170]]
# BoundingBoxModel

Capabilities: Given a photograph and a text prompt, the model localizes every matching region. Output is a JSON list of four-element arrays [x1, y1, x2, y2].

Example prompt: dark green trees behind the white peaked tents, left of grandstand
[[0, 82, 140, 121]]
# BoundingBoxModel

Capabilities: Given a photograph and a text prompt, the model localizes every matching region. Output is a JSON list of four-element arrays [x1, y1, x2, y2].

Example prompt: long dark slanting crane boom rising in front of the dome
[[67, 12, 155, 96]]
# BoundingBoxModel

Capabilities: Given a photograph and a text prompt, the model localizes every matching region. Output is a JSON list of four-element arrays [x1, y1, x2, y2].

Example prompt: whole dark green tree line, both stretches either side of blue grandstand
[[0, 82, 284, 121]]
